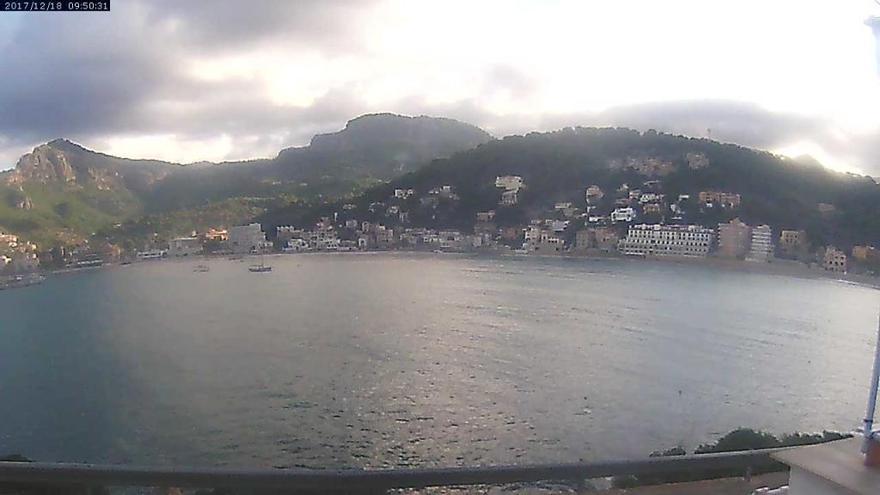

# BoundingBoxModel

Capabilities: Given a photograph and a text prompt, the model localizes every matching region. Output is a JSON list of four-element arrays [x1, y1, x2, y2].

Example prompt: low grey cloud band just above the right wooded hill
[[405, 100, 880, 175]]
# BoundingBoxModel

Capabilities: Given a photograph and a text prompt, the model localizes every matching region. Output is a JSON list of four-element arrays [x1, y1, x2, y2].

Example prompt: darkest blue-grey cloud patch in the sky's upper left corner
[[0, 5, 175, 139]]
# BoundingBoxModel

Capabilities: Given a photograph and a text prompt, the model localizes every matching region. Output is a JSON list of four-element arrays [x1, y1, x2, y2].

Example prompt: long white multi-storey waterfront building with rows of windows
[[619, 224, 714, 256]]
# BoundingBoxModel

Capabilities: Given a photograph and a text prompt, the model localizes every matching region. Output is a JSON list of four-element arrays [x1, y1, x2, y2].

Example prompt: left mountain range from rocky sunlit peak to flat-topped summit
[[0, 114, 492, 244]]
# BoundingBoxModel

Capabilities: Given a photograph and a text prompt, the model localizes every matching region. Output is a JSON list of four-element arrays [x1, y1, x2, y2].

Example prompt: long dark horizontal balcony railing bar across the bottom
[[0, 449, 785, 493]]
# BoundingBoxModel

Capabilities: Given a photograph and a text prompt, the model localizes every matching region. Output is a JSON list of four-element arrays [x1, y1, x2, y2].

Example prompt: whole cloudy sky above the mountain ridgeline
[[0, 0, 880, 176]]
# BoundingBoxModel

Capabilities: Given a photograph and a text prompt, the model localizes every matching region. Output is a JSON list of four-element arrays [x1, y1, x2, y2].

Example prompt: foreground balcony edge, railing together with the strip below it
[[0, 449, 791, 495]]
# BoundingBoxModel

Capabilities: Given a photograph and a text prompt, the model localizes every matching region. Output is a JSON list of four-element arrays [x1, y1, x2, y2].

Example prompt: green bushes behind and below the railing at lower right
[[614, 428, 852, 488]]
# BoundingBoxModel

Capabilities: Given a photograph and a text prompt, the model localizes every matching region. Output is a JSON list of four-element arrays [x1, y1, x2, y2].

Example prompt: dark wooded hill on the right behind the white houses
[[261, 128, 880, 252]]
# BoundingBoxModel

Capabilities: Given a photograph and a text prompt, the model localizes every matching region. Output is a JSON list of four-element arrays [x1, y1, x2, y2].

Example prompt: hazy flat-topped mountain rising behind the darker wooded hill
[[148, 113, 492, 211]]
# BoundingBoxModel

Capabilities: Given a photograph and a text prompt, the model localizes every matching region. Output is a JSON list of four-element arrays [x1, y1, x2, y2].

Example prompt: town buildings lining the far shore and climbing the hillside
[[6, 172, 880, 282]]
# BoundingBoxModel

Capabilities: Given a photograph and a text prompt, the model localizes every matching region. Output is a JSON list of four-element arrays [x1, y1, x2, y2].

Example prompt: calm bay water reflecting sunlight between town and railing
[[0, 253, 880, 468]]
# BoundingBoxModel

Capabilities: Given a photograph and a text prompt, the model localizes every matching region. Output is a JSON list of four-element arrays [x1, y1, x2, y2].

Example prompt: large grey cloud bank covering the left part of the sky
[[0, 0, 378, 165]]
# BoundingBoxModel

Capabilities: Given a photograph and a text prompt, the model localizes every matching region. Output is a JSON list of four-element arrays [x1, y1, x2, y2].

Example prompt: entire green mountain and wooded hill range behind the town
[[8, 123, 880, 258]]
